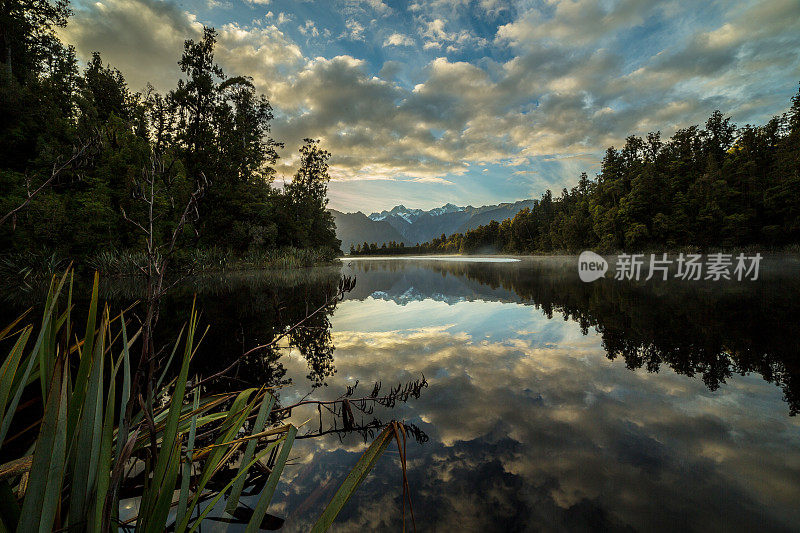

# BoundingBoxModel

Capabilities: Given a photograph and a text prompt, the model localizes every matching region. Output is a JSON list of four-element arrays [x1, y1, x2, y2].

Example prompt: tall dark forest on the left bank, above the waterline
[[0, 0, 339, 270]]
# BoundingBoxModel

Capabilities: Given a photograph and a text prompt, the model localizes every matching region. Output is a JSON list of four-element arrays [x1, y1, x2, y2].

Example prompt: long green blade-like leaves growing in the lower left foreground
[[0, 270, 400, 533]]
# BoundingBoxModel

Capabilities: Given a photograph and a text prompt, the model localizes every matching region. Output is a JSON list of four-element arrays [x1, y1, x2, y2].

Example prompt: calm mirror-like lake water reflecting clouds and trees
[[6, 258, 800, 531]]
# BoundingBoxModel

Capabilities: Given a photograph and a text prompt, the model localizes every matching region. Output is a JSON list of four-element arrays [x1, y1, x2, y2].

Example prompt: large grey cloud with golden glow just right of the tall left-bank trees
[[273, 56, 494, 179]]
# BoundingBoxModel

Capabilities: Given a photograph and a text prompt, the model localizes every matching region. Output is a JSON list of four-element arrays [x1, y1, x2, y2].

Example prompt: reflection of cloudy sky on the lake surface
[[280, 298, 800, 531]]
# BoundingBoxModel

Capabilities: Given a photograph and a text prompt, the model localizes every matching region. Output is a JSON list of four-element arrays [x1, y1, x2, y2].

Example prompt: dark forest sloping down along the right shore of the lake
[[350, 92, 800, 255]]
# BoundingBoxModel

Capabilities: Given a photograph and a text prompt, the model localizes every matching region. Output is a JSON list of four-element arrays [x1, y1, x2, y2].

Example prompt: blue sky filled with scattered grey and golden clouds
[[62, 0, 800, 213]]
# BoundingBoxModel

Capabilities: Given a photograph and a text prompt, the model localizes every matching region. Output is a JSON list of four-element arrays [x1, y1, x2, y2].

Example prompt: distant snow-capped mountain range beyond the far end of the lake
[[330, 200, 536, 251]]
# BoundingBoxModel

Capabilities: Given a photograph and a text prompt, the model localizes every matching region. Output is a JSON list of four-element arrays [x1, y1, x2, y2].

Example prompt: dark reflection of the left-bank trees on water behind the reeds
[[162, 268, 340, 388]]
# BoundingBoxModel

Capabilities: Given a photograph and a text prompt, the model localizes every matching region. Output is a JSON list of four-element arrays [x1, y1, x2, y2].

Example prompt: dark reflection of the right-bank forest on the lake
[[352, 258, 800, 415]]
